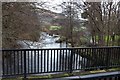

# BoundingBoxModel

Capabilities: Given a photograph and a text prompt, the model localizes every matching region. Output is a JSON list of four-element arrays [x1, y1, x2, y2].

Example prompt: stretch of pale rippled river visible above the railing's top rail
[[18, 32, 66, 49]]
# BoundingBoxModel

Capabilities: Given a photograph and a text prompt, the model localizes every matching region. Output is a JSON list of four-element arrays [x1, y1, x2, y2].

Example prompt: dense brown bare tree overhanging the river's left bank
[[2, 2, 44, 48]]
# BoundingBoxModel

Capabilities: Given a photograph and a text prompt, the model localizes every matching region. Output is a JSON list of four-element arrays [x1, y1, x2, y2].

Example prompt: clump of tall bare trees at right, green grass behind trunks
[[80, 2, 119, 46]]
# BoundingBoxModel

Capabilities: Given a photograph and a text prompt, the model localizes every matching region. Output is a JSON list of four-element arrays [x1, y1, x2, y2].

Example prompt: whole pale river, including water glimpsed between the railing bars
[[18, 32, 82, 71]]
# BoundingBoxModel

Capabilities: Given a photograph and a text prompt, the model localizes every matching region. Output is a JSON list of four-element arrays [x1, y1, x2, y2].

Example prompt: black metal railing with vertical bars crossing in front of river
[[2, 47, 120, 77]]
